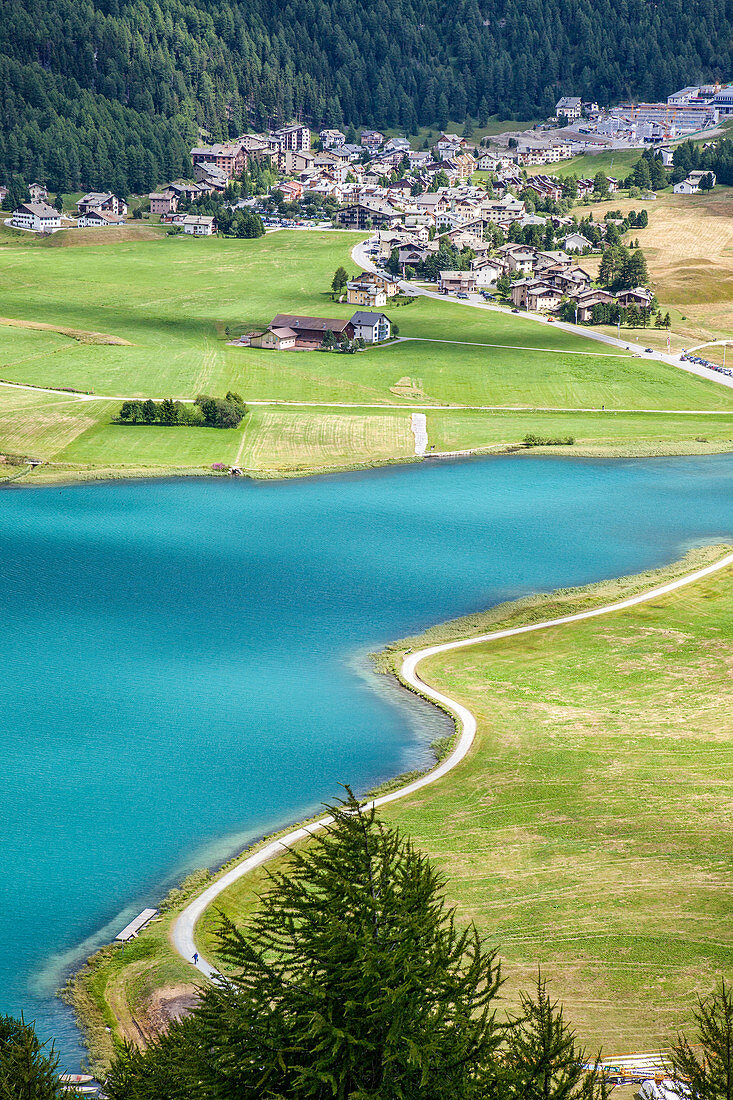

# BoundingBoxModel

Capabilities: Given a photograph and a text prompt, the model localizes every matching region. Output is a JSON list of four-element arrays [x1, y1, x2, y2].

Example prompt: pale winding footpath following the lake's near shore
[[171, 553, 733, 979]]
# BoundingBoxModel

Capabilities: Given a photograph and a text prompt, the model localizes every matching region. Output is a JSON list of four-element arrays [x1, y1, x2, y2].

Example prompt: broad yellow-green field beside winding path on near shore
[[186, 548, 733, 1054]]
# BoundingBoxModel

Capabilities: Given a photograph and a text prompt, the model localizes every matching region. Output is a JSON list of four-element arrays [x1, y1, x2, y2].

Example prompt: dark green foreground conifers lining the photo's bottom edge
[[0, 791, 733, 1100]]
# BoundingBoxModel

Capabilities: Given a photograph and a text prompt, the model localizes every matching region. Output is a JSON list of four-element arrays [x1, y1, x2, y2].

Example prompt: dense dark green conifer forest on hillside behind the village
[[0, 0, 733, 191]]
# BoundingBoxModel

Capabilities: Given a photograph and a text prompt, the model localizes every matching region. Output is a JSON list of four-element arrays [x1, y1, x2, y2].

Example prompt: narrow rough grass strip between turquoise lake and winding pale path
[[64, 543, 731, 1068]]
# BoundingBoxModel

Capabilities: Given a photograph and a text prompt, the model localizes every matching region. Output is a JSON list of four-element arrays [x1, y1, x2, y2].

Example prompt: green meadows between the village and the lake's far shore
[[0, 227, 733, 476]]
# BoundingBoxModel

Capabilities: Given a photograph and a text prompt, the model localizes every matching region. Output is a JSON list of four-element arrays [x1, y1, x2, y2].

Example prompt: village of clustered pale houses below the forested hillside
[[0, 85, 733, 341]]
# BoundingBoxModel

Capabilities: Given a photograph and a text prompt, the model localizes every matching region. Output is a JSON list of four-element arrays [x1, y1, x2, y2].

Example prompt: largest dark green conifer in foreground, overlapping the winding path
[[107, 793, 502, 1100]]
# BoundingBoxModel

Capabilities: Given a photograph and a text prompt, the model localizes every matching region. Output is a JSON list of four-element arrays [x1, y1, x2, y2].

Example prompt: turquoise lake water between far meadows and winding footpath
[[0, 455, 733, 1068]]
